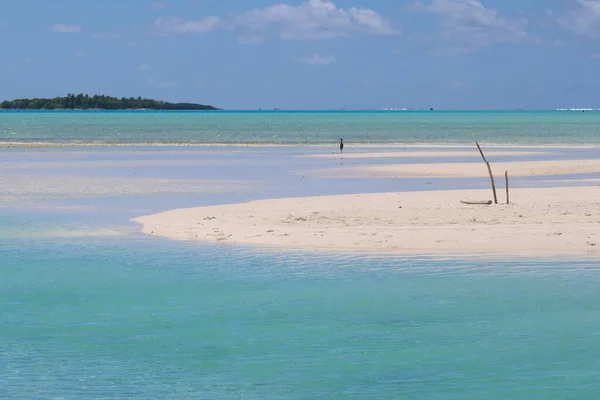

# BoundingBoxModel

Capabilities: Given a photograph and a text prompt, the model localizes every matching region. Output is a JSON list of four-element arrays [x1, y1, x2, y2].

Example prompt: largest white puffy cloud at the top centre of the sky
[[234, 0, 396, 40]]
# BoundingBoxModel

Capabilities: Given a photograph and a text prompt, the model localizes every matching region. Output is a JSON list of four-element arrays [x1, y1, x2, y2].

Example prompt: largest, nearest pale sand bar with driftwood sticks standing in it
[[134, 187, 600, 255]]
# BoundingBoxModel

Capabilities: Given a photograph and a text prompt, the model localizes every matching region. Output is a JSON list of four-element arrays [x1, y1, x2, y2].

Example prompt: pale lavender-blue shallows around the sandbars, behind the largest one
[[0, 147, 600, 238]]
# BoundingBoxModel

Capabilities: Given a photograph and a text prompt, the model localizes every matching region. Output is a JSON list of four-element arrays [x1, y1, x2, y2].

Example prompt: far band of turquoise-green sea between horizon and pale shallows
[[0, 111, 600, 144]]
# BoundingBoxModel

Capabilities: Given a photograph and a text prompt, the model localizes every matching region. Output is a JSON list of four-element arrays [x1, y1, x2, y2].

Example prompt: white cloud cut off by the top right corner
[[556, 0, 600, 39]]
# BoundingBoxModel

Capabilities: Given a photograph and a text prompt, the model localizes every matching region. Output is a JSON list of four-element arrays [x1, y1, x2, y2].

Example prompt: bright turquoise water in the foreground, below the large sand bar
[[0, 239, 600, 399]]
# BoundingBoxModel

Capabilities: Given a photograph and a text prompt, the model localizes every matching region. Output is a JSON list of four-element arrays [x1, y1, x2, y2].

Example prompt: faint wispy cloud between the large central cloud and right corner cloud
[[413, 0, 535, 54]]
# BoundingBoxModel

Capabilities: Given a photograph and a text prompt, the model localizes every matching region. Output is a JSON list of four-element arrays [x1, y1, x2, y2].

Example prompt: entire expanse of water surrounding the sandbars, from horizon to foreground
[[0, 112, 600, 400]]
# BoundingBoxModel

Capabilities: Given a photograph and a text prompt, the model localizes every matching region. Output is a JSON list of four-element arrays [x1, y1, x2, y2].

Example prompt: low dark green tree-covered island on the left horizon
[[0, 93, 218, 110]]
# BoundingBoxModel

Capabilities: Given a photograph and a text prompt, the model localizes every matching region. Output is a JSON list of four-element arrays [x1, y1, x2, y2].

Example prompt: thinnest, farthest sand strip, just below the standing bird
[[298, 149, 548, 159]]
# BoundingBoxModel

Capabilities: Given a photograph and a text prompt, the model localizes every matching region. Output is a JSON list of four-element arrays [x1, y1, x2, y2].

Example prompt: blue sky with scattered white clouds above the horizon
[[0, 0, 600, 109]]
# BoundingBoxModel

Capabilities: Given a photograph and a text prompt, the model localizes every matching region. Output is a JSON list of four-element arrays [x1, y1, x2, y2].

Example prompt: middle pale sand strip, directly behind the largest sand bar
[[318, 159, 600, 178]]
